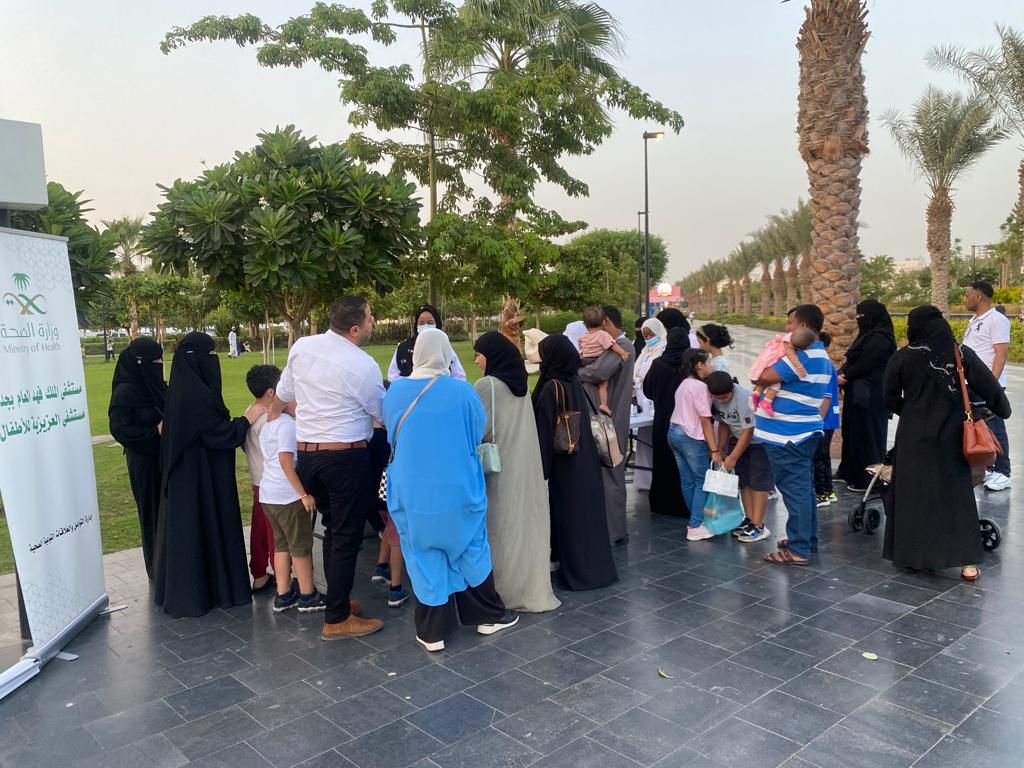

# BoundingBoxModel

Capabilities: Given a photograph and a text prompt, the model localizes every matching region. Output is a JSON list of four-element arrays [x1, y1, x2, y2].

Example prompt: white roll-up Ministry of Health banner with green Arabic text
[[0, 228, 108, 697]]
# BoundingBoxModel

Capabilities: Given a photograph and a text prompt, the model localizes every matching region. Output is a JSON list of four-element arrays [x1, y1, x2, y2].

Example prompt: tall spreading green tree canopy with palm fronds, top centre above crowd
[[162, 0, 682, 300]]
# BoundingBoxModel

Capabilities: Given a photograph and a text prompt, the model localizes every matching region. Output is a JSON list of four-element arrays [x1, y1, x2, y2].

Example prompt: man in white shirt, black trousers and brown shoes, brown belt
[[267, 296, 384, 640]]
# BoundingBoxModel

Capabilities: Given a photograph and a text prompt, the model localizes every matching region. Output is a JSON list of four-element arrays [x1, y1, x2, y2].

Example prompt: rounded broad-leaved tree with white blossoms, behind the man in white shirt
[[144, 126, 421, 341]]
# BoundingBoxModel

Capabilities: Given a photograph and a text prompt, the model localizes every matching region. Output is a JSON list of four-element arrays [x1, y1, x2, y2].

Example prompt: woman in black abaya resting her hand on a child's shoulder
[[154, 332, 266, 617]]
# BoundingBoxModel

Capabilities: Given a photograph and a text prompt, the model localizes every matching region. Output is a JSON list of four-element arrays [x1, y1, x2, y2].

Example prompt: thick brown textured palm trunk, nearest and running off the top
[[797, 0, 868, 355]]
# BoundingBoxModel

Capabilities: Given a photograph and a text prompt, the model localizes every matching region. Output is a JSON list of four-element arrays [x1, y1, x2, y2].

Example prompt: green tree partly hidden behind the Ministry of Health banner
[[10, 181, 115, 323]]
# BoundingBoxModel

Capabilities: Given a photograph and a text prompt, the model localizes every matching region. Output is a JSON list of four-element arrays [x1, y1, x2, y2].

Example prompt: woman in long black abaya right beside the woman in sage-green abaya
[[534, 334, 618, 590]]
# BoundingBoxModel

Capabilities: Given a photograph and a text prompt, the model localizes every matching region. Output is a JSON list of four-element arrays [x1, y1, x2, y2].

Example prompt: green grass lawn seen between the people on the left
[[0, 341, 481, 573]]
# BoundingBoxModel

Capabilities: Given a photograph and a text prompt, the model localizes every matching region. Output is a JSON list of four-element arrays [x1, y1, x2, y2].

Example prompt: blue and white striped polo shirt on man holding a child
[[754, 341, 836, 445]]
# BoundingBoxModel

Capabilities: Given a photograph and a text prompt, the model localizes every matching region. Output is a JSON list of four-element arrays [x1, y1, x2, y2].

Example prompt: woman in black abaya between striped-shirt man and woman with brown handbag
[[836, 299, 896, 490]]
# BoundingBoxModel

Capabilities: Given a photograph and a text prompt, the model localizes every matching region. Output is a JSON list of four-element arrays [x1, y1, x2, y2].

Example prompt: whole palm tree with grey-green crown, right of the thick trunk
[[882, 91, 1007, 311]]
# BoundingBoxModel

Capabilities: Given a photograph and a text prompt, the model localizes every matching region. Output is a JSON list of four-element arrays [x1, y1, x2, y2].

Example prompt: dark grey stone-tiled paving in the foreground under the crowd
[[0, 331, 1024, 768]]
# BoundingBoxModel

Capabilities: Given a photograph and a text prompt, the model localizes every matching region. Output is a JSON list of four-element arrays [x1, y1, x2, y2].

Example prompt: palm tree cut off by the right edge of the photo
[[928, 25, 1024, 264]]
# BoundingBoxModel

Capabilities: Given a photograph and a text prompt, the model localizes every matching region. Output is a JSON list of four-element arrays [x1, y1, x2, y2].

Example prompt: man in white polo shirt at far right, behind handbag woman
[[964, 281, 1010, 490]]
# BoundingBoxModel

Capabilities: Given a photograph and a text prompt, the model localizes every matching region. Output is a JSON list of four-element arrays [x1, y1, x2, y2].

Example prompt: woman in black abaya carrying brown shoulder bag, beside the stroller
[[882, 306, 1010, 582]]
